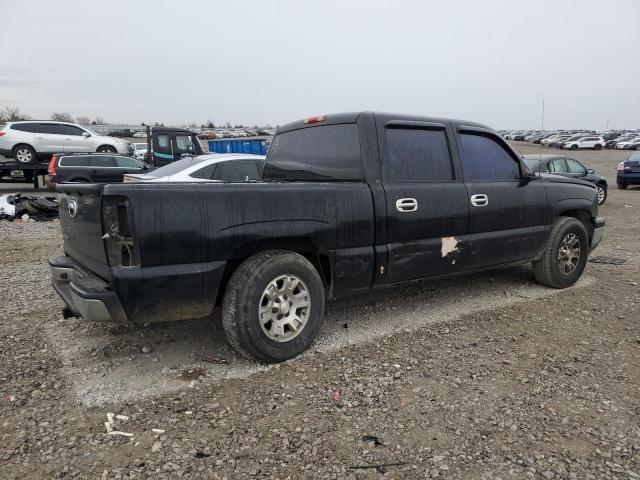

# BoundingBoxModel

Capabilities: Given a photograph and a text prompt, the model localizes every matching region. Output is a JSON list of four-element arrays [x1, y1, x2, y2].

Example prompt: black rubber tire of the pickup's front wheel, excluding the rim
[[533, 217, 589, 288]]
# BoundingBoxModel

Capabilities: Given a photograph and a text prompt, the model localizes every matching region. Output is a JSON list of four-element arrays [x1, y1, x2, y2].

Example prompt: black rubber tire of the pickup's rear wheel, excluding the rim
[[222, 250, 325, 363]]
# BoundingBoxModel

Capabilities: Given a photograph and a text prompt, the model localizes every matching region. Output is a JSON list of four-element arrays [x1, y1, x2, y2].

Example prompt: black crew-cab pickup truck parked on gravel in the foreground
[[49, 112, 604, 362]]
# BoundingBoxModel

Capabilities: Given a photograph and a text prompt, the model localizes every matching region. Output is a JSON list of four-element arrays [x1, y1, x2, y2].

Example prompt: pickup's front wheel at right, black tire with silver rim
[[533, 217, 589, 288]]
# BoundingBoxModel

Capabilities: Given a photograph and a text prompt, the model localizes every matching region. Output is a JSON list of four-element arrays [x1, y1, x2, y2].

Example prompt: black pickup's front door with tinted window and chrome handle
[[459, 129, 549, 268]]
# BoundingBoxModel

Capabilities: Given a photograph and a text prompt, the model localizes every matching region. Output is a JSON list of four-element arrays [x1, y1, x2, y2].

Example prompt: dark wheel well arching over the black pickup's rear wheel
[[216, 239, 333, 305]]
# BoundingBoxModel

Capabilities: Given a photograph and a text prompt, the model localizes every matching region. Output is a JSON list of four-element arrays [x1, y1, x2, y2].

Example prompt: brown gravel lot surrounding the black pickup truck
[[0, 144, 640, 480]]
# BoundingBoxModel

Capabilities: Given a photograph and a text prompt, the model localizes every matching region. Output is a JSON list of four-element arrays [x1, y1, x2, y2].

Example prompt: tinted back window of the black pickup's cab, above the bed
[[264, 123, 362, 181]]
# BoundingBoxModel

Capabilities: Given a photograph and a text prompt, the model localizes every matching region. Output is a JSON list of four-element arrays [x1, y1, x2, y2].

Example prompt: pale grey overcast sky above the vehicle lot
[[0, 0, 640, 128]]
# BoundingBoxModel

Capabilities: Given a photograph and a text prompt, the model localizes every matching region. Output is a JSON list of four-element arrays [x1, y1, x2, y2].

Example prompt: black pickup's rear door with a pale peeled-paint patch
[[378, 121, 469, 283]]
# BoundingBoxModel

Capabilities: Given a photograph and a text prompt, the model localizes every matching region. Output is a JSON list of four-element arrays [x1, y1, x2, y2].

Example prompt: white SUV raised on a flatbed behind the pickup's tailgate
[[0, 120, 133, 163]]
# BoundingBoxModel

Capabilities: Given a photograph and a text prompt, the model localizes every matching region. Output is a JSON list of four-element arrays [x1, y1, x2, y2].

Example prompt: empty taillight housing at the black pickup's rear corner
[[102, 196, 140, 267]]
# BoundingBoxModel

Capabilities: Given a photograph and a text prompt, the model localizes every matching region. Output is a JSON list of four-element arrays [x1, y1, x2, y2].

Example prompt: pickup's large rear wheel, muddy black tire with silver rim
[[222, 250, 325, 363]]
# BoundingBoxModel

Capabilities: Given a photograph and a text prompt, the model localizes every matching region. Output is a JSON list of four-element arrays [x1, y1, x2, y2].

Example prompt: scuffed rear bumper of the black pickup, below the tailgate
[[49, 257, 128, 322]]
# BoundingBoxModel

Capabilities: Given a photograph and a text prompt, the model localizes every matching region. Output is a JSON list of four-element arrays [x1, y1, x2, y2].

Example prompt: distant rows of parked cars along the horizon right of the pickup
[[500, 130, 640, 150]]
